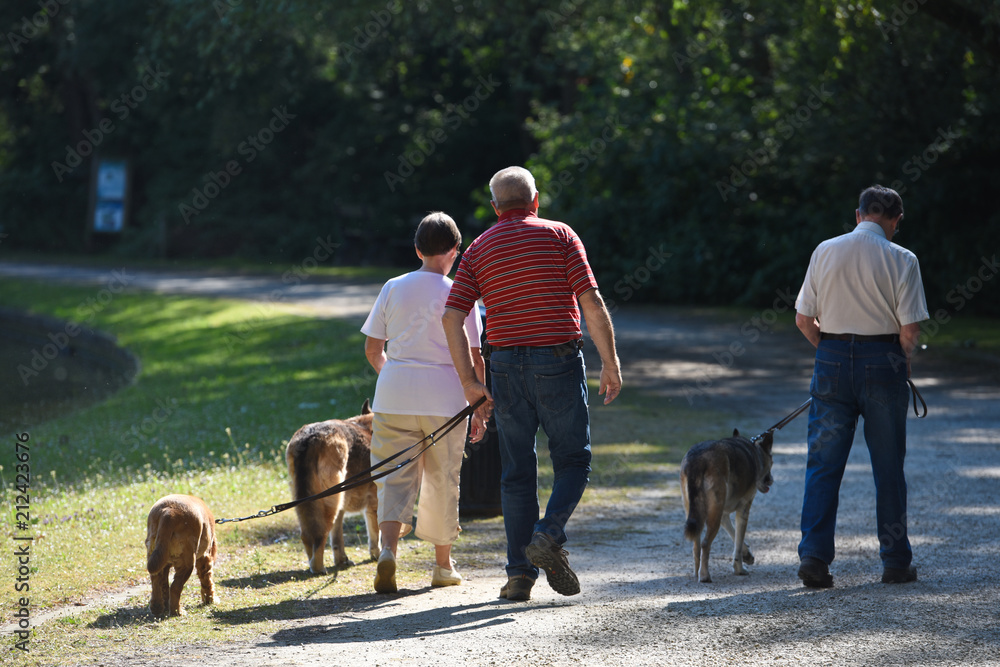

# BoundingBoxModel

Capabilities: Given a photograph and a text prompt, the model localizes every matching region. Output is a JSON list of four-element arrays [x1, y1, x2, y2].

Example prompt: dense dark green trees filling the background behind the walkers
[[0, 0, 1000, 313]]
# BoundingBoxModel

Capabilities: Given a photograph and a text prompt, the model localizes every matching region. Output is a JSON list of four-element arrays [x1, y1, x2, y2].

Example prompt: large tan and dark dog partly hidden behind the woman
[[285, 400, 381, 574]]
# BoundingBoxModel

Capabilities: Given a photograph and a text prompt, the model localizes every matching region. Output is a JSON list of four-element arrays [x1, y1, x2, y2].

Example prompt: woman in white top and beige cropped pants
[[361, 212, 485, 593]]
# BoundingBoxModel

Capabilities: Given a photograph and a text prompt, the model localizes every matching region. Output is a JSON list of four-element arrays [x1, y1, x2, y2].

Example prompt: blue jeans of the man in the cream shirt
[[799, 340, 913, 568]]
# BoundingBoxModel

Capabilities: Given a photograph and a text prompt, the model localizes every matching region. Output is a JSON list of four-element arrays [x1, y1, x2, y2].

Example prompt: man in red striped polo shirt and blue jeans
[[442, 167, 622, 600]]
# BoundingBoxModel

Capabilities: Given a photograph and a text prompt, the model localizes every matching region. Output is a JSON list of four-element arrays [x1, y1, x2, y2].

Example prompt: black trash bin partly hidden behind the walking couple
[[458, 317, 503, 518]]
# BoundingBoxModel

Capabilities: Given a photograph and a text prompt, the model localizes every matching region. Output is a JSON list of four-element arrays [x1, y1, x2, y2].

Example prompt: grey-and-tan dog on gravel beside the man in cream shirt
[[681, 429, 774, 583]]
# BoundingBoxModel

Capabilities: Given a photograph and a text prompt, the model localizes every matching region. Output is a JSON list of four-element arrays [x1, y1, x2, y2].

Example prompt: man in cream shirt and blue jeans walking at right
[[795, 185, 928, 588]]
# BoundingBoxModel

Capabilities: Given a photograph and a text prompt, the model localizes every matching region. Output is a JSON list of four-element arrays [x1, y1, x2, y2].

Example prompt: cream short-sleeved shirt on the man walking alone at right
[[795, 221, 929, 336]]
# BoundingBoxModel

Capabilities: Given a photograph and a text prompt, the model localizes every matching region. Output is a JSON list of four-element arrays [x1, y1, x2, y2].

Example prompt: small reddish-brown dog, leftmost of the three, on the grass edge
[[146, 495, 218, 616]]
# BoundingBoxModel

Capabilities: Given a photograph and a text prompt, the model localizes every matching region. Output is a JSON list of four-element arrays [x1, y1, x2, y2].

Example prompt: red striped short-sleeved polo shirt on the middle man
[[445, 210, 597, 346]]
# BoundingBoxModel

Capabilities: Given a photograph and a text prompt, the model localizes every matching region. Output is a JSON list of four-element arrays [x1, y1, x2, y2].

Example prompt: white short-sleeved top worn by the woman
[[361, 271, 483, 417]]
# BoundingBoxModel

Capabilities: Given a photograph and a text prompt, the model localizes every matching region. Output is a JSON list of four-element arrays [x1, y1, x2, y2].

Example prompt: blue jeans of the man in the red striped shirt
[[490, 347, 590, 579]]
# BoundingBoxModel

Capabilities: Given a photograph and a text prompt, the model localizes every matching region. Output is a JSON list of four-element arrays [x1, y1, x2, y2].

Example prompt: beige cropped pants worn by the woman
[[372, 412, 466, 545]]
